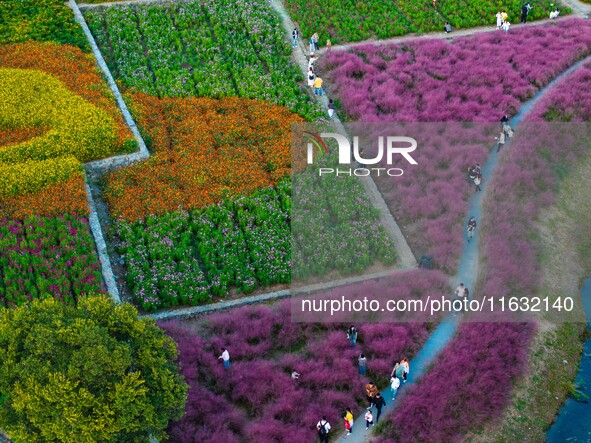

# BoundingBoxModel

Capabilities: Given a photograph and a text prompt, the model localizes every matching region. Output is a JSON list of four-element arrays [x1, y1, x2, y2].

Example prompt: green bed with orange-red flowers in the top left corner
[[0, 0, 89, 50]]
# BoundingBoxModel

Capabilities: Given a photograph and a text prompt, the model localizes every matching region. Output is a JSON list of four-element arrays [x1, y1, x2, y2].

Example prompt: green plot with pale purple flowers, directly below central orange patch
[[115, 174, 396, 311]]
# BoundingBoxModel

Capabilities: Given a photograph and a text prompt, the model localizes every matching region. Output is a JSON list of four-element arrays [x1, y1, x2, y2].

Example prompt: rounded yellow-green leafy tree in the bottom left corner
[[0, 296, 187, 443]]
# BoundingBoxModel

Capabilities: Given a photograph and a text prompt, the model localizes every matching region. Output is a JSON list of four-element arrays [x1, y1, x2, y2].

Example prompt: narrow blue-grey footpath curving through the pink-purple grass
[[334, 56, 591, 443]]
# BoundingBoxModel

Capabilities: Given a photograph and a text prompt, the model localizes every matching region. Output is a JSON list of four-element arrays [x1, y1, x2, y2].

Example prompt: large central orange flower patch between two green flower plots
[[104, 93, 303, 221]]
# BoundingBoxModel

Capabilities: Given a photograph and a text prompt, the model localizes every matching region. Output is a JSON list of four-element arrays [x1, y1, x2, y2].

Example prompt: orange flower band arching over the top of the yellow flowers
[[0, 41, 135, 151]]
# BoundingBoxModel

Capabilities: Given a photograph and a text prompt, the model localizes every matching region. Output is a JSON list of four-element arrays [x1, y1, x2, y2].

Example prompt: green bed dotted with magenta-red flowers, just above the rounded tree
[[0, 215, 102, 307]]
